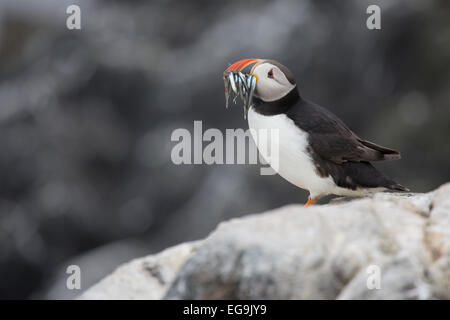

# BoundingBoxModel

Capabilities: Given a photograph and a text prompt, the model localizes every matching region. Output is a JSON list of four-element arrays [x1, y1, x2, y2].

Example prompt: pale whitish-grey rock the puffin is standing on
[[81, 184, 450, 299]]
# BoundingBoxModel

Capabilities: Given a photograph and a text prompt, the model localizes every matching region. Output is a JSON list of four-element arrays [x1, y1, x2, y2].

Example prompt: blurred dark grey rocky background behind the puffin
[[0, 0, 450, 299]]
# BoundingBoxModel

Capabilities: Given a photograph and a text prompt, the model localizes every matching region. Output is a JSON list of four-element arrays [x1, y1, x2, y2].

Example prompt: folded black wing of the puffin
[[286, 100, 400, 164]]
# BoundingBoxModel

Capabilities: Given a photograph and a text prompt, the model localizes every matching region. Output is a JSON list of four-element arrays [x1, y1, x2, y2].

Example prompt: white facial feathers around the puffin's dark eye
[[253, 62, 295, 102]]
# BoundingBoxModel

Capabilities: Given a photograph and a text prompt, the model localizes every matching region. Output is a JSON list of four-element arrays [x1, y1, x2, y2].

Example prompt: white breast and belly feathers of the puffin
[[248, 107, 336, 197]]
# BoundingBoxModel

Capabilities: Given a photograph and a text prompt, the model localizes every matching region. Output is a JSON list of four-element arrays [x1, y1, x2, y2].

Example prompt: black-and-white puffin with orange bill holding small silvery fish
[[224, 59, 409, 207]]
